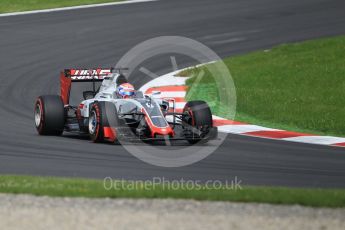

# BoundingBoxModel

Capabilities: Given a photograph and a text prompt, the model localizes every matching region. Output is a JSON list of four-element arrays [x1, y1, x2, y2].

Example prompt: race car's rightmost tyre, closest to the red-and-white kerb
[[183, 101, 213, 144]]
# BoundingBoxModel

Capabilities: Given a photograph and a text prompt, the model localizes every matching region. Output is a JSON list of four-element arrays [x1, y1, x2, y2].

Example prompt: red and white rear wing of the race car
[[60, 68, 114, 105]]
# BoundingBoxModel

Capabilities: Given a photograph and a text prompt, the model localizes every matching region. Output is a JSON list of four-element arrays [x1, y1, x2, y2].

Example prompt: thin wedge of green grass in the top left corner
[[0, 0, 123, 13]]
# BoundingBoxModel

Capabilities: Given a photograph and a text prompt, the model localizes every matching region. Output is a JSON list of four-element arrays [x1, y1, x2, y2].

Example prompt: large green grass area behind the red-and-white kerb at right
[[181, 36, 345, 136]]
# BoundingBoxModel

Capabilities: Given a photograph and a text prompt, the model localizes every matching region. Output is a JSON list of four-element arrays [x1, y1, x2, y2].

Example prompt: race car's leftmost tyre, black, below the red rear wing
[[34, 95, 65, 136]]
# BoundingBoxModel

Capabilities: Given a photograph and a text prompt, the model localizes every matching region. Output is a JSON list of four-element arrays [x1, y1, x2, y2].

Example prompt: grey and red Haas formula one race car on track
[[34, 69, 218, 144]]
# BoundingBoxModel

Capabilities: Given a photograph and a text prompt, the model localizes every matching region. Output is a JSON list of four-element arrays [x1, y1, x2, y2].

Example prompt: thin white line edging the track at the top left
[[0, 0, 158, 17]]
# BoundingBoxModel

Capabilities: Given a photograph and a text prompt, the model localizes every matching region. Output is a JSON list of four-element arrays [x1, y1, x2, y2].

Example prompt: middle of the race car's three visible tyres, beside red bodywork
[[89, 101, 118, 143]]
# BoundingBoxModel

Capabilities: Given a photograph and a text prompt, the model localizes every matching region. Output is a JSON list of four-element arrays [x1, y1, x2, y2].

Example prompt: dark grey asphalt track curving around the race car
[[0, 0, 345, 187]]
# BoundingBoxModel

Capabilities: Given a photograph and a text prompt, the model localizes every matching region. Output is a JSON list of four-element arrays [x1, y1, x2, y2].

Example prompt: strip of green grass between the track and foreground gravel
[[0, 175, 345, 207]]
